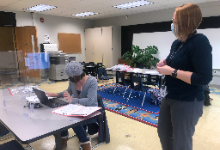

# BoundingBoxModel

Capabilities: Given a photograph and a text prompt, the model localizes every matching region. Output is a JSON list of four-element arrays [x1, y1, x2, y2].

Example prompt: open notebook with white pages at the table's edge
[[52, 104, 101, 117]]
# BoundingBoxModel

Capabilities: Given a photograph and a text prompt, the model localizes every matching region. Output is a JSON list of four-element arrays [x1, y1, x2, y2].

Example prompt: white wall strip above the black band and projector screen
[[94, 1, 220, 27]]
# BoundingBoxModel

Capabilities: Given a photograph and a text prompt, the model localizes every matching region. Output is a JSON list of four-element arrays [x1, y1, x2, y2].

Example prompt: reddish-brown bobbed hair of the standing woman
[[174, 3, 202, 40]]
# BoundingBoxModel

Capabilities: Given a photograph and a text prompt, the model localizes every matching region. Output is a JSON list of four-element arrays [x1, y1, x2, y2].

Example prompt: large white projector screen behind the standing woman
[[132, 28, 220, 69]]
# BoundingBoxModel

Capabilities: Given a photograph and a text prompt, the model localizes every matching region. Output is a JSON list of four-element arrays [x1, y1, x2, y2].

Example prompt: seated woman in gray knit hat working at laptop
[[46, 61, 98, 150]]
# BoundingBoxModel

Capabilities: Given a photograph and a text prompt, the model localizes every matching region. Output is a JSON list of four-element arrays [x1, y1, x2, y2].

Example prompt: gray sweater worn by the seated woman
[[59, 76, 98, 106]]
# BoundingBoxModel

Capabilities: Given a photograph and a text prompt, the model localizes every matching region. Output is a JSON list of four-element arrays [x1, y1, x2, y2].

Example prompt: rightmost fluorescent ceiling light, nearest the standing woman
[[113, 0, 153, 9]]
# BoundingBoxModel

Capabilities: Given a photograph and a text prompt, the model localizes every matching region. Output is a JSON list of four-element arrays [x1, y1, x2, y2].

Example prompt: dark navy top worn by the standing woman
[[165, 34, 212, 101]]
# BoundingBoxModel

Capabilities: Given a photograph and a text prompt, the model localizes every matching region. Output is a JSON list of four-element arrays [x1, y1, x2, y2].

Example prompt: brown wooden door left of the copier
[[15, 26, 41, 82]]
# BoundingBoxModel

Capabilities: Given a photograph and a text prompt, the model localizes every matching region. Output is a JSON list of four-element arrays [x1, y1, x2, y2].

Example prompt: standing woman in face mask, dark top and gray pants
[[157, 4, 212, 150]]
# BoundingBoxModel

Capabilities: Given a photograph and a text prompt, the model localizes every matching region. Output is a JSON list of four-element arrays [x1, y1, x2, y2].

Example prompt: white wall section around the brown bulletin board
[[15, 12, 93, 61]]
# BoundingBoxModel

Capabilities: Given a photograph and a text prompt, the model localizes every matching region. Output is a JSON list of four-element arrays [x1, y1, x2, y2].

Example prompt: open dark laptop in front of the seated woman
[[33, 88, 69, 108]]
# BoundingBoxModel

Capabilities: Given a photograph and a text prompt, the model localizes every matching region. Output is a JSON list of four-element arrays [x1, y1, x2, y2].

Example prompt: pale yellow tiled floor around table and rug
[[0, 79, 220, 150]]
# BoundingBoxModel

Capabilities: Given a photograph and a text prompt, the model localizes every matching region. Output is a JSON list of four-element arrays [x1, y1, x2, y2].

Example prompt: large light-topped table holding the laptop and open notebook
[[0, 89, 101, 150]]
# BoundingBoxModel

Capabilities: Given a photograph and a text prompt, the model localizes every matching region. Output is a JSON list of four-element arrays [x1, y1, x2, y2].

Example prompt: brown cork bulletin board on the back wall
[[58, 33, 82, 54]]
